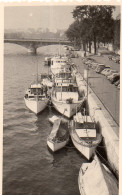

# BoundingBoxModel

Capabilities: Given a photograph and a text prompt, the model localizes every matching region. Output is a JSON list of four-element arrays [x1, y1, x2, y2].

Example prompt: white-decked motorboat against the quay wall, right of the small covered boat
[[70, 112, 102, 160]]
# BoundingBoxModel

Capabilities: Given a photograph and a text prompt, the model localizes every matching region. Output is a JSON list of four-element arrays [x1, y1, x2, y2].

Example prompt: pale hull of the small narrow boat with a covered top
[[47, 139, 68, 152]]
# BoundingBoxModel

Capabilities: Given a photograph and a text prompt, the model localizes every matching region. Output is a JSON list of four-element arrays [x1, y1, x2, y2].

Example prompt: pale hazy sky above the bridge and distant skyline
[[4, 5, 120, 32]]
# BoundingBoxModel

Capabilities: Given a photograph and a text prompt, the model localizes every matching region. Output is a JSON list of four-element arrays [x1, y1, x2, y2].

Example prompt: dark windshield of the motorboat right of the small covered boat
[[75, 122, 96, 129]]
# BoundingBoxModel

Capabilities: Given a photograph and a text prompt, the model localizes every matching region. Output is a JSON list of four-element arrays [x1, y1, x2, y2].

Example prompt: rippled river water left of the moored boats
[[2, 44, 86, 195]]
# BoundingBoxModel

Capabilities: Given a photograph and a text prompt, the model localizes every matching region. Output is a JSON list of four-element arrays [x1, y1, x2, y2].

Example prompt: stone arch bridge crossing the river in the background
[[4, 39, 73, 54]]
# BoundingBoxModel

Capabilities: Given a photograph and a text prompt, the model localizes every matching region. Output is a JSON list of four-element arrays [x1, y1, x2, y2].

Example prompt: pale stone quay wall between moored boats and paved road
[[76, 73, 119, 177]]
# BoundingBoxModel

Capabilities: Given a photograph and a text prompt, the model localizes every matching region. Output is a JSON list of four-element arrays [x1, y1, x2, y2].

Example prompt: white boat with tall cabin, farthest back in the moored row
[[51, 56, 71, 76]]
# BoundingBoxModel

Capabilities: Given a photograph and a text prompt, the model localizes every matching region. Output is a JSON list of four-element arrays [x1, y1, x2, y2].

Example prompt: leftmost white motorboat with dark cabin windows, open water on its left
[[24, 83, 48, 114]]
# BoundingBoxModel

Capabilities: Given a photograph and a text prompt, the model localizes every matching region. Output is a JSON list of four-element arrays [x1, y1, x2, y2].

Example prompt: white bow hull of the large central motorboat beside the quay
[[51, 97, 84, 118]]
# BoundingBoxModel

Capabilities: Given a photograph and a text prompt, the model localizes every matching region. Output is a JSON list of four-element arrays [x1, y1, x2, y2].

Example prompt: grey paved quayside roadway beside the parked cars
[[72, 55, 120, 126]]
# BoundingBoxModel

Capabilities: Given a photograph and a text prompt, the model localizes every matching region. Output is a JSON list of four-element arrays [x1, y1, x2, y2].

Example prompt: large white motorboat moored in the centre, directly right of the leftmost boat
[[51, 78, 85, 118]]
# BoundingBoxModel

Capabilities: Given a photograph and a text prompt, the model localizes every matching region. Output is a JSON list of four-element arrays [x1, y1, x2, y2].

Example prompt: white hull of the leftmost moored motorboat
[[24, 98, 48, 114]]
